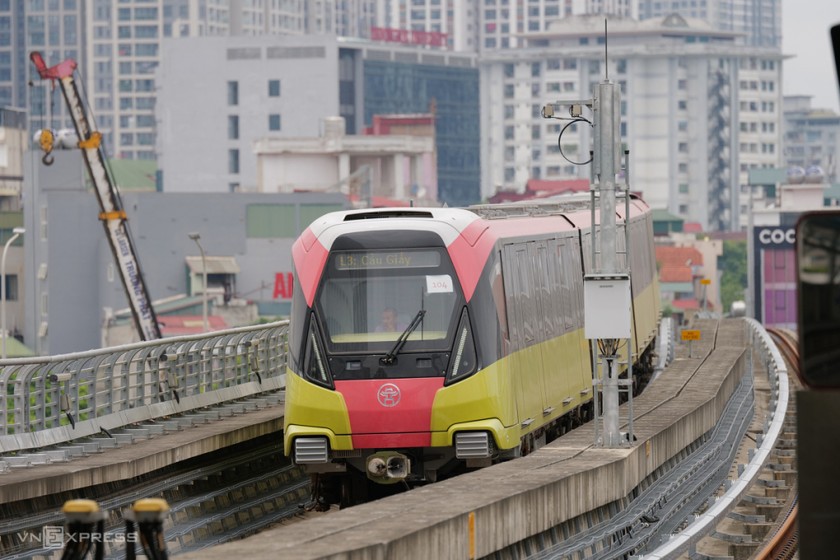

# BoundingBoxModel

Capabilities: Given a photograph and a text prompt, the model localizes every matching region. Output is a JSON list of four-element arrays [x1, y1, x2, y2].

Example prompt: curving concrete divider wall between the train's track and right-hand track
[[185, 320, 750, 559]]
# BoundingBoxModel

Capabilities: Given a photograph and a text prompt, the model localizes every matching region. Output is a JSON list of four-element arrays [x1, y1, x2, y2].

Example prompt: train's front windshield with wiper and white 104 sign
[[317, 247, 463, 354]]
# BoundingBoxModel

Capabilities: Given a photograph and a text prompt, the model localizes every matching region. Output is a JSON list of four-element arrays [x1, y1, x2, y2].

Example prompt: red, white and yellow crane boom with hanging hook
[[29, 51, 161, 340]]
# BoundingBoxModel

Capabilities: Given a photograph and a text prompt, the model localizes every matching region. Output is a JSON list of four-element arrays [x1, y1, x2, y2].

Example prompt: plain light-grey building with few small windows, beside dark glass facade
[[157, 36, 338, 192]]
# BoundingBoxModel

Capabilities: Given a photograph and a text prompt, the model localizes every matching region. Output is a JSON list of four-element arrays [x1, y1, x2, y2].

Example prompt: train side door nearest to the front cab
[[502, 243, 543, 429]]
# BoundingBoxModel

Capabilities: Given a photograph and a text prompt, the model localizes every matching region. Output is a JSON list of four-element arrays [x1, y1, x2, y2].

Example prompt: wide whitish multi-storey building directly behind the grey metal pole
[[481, 14, 782, 230]]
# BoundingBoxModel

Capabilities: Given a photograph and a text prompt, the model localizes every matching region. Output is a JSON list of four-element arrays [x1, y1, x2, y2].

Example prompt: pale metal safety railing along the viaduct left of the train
[[0, 321, 289, 453]]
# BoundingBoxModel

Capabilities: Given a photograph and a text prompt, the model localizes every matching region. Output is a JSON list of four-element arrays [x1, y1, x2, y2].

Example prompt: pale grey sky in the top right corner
[[782, 0, 840, 113]]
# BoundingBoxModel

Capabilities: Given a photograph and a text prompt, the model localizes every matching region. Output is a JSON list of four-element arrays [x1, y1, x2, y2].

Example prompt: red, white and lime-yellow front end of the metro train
[[284, 209, 495, 505]]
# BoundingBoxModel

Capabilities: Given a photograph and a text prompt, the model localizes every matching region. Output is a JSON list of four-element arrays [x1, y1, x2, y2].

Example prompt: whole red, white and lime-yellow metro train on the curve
[[284, 196, 660, 506]]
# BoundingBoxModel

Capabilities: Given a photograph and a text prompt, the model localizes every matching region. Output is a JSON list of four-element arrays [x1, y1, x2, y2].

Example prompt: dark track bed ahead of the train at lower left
[[0, 436, 313, 559]]
